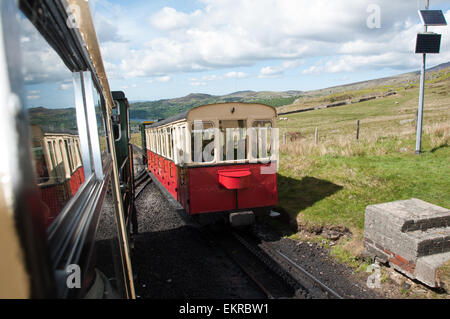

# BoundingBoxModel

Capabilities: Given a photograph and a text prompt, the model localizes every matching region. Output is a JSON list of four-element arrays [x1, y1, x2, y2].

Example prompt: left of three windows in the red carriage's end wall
[[191, 121, 214, 163]]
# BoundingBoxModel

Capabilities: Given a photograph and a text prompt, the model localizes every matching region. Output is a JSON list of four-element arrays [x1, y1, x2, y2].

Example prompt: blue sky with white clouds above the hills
[[23, 0, 450, 107]]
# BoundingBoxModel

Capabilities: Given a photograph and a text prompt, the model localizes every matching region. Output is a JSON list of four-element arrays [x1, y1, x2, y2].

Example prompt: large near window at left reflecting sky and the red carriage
[[21, 14, 88, 227]]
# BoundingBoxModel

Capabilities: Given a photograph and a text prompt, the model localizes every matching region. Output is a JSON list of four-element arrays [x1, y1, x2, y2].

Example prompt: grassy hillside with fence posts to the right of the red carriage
[[278, 69, 450, 270]]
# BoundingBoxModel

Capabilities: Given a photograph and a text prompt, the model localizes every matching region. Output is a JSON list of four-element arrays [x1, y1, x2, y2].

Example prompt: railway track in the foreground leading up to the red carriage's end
[[202, 227, 344, 299]]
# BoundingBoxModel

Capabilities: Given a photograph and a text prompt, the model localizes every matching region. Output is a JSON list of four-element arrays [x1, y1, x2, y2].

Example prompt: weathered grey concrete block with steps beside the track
[[364, 199, 450, 287]]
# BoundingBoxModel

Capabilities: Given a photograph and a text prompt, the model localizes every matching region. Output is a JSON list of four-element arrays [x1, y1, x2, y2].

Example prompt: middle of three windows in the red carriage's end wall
[[219, 120, 247, 161]]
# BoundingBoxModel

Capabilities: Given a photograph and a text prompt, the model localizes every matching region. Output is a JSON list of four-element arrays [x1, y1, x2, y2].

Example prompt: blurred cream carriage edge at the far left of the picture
[[0, 1, 31, 299]]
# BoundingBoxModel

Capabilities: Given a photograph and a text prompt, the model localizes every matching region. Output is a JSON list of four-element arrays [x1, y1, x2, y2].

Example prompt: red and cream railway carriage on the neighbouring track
[[145, 103, 278, 222]]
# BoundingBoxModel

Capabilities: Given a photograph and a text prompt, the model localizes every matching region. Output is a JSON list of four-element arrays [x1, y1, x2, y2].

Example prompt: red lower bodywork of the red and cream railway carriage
[[147, 150, 278, 215]]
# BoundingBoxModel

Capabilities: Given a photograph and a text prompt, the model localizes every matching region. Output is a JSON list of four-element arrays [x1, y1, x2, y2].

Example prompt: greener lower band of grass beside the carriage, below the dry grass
[[278, 145, 450, 231]]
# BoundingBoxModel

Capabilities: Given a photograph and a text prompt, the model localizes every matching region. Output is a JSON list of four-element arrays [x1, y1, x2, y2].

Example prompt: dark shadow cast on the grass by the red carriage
[[260, 175, 343, 236]]
